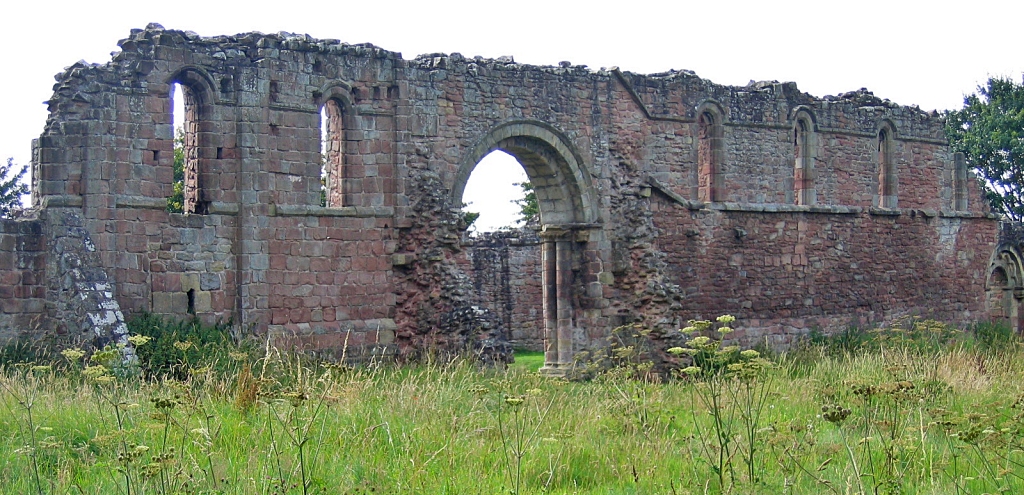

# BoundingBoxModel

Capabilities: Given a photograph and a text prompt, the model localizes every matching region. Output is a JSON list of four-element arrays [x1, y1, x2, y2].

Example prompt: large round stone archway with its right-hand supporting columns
[[453, 121, 598, 375]]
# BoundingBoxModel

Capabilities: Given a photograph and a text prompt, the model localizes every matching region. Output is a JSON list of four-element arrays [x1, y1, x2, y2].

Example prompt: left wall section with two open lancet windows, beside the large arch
[[35, 28, 395, 347]]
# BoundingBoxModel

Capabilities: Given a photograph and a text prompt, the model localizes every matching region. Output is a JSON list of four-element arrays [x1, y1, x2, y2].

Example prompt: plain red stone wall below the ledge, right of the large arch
[[651, 194, 995, 345]]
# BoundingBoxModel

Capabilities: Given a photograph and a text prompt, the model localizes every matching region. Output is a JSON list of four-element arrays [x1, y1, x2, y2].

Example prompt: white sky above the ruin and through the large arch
[[0, 0, 1024, 225]]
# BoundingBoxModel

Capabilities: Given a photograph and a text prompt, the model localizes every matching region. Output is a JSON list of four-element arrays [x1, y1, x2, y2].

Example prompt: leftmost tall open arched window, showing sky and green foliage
[[167, 82, 206, 215]]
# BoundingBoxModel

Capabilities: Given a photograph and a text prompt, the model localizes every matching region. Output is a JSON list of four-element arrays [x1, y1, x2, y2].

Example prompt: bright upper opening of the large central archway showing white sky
[[462, 151, 539, 233]]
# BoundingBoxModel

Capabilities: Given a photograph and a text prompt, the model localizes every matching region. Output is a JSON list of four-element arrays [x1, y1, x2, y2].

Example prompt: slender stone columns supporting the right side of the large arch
[[540, 226, 573, 376]]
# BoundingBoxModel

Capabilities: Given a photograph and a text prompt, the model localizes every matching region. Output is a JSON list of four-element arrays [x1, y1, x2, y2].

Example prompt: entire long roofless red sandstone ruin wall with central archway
[[0, 25, 997, 364]]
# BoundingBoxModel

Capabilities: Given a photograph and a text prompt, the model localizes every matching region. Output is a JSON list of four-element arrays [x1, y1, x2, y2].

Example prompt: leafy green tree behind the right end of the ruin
[[946, 77, 1024, 221]]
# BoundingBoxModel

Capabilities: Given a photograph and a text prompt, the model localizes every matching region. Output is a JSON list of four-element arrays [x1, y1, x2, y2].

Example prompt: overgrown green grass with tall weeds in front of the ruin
[[0, 323, 1024, 495]]
